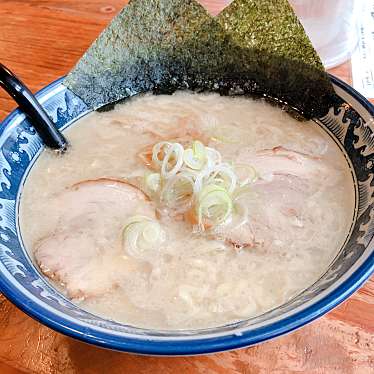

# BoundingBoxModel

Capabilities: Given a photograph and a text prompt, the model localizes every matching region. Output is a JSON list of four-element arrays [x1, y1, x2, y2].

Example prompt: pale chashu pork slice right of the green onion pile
[[220, 146, 338, 248]]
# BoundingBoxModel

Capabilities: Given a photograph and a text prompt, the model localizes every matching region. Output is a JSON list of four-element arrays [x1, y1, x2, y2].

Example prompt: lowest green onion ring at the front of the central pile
[[197, 184, 233, 225]]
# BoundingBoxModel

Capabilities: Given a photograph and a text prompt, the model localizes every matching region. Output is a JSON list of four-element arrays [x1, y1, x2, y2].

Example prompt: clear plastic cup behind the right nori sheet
[[289, 0, 365, 69]]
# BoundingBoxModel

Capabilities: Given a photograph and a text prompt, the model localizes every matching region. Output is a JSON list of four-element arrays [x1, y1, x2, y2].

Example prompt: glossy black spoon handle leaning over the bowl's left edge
[[0, 63, 68, 151]]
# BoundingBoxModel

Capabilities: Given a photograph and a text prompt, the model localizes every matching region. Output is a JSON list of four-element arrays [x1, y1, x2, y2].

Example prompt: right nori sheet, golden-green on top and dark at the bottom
[[217, 0, 337, 117]]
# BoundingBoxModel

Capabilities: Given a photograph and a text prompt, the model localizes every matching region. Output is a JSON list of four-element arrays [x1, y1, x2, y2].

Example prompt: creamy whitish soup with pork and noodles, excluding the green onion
[[20, 92, 354, 329]]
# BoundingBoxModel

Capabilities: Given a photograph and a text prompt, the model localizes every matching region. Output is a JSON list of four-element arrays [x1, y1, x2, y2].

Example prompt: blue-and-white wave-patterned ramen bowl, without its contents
[[0, 77, 374, 355]]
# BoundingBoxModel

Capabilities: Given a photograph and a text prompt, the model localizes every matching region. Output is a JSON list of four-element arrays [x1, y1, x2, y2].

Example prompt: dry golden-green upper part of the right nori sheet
[[221, 0, 324, 68]]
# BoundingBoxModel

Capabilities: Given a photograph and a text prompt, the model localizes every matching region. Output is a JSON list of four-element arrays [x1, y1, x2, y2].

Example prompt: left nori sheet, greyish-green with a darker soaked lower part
[[64, 0, 228, 109]]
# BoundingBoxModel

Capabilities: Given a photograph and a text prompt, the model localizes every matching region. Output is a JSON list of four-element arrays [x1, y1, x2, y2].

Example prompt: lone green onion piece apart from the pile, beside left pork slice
[[123, 216, 165, 259]]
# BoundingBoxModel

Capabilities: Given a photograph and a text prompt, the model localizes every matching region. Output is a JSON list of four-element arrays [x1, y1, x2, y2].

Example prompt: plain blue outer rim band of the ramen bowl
[[0, 75, 374, 356]]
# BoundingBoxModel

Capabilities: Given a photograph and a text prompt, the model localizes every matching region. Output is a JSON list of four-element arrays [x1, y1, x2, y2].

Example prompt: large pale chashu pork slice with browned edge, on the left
[[34, 179, 155, 298]]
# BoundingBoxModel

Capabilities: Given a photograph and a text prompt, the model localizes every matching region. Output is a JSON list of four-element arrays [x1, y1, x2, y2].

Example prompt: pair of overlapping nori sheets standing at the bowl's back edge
[[64, 0, 333, 118]]
